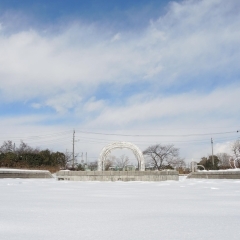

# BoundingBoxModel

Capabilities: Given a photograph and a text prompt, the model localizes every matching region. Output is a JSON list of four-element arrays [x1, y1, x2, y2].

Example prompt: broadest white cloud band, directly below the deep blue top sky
[[0, 0, 240, 107]]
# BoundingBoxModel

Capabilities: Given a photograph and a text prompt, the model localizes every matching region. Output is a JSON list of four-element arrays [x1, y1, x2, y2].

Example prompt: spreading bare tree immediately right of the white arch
[[143, 144, 182, 170]]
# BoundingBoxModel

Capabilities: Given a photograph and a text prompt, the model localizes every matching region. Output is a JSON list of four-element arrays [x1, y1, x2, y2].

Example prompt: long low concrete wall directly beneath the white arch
[[56, 170, 179, 181]]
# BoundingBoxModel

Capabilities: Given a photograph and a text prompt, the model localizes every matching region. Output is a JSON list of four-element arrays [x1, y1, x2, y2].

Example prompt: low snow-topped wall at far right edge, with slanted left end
[[187, 170, 240, 179]]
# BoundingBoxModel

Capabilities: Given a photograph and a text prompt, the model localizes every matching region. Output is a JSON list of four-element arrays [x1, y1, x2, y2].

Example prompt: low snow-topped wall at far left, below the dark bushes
[[0, 168, 53, 178]]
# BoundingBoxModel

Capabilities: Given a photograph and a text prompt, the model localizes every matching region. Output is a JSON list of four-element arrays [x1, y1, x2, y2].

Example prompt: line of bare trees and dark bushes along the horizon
[[0, 140, 240, 172]]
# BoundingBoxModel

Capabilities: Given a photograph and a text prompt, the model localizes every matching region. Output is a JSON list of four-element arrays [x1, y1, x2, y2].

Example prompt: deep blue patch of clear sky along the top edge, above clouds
[[0, 0, 172, 30]]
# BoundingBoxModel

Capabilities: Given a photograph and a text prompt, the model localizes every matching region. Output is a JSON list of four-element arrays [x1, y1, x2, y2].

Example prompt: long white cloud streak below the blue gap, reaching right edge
[[84, 85, 240, 126]]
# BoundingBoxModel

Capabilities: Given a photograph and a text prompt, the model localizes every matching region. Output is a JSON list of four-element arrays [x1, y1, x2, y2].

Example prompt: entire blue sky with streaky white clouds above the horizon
[[0, 0, 240, 161]]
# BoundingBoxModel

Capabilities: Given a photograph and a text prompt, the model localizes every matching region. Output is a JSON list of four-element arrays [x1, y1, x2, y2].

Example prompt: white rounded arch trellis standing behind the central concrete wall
[[98, 142, 145, 171]]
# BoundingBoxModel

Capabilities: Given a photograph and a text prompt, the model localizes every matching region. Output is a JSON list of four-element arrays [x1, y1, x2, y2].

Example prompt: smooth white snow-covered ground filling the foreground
[[0, 177, 240, 240]]
